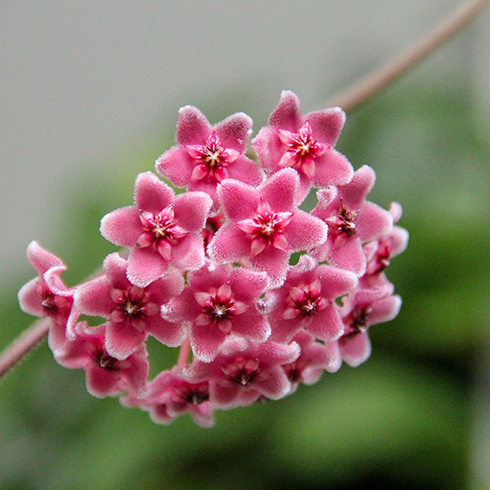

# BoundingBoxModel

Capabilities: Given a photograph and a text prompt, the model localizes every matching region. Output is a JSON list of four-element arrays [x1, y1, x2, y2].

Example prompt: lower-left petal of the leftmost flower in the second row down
[[127, 247, 168, 288]]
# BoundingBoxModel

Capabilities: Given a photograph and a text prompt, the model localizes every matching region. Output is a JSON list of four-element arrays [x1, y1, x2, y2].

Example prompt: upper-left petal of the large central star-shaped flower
[[218, 179, 259, 221]]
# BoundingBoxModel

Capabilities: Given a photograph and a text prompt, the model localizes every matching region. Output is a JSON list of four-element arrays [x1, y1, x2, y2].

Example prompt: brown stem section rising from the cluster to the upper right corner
[[327, 0, 490, 112]]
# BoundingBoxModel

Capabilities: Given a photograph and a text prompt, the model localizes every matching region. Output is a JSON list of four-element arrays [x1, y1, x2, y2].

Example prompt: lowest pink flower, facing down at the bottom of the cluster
[[121, 367, 214, 427]]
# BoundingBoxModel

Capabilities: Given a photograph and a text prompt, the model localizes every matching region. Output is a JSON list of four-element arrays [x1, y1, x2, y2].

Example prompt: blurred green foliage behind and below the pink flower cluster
[[0, 68, 490, 490]]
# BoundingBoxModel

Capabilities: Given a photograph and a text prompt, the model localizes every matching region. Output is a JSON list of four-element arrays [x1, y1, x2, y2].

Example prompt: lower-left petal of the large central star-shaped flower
[[208, 223, 251, 263]]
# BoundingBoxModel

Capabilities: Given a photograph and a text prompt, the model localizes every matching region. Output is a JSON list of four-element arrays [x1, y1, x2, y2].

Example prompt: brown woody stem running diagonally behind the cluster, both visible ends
[[0, 0, 490, 378]]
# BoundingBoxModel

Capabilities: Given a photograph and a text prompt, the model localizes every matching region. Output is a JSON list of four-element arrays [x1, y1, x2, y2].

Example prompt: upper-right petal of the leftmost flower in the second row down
[[174, 192, 213, 231]]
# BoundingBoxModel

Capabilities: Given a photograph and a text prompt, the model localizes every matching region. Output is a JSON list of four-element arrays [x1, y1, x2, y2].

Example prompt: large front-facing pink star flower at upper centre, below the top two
[[208, 169, 327, 287]]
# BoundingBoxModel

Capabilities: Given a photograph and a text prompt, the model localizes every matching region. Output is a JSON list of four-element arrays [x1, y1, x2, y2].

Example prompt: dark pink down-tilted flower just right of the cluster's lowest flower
[[183, 337, 300, 409]]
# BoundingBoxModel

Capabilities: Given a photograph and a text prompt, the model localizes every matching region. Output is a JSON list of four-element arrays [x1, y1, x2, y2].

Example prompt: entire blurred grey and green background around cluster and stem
[[0, 0, 490, 490]]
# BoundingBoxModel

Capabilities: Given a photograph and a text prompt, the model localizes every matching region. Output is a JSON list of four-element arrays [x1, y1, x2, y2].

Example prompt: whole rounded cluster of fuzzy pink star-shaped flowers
[[19, 91, 408, 427]]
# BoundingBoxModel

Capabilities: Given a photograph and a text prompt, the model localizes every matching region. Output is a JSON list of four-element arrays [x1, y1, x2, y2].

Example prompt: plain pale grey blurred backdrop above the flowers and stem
[[0, 0, 490, 285]]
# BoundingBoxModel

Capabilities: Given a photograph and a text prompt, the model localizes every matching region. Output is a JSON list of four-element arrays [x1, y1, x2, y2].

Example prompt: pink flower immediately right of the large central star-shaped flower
[[311, 165, 392, 276]]
